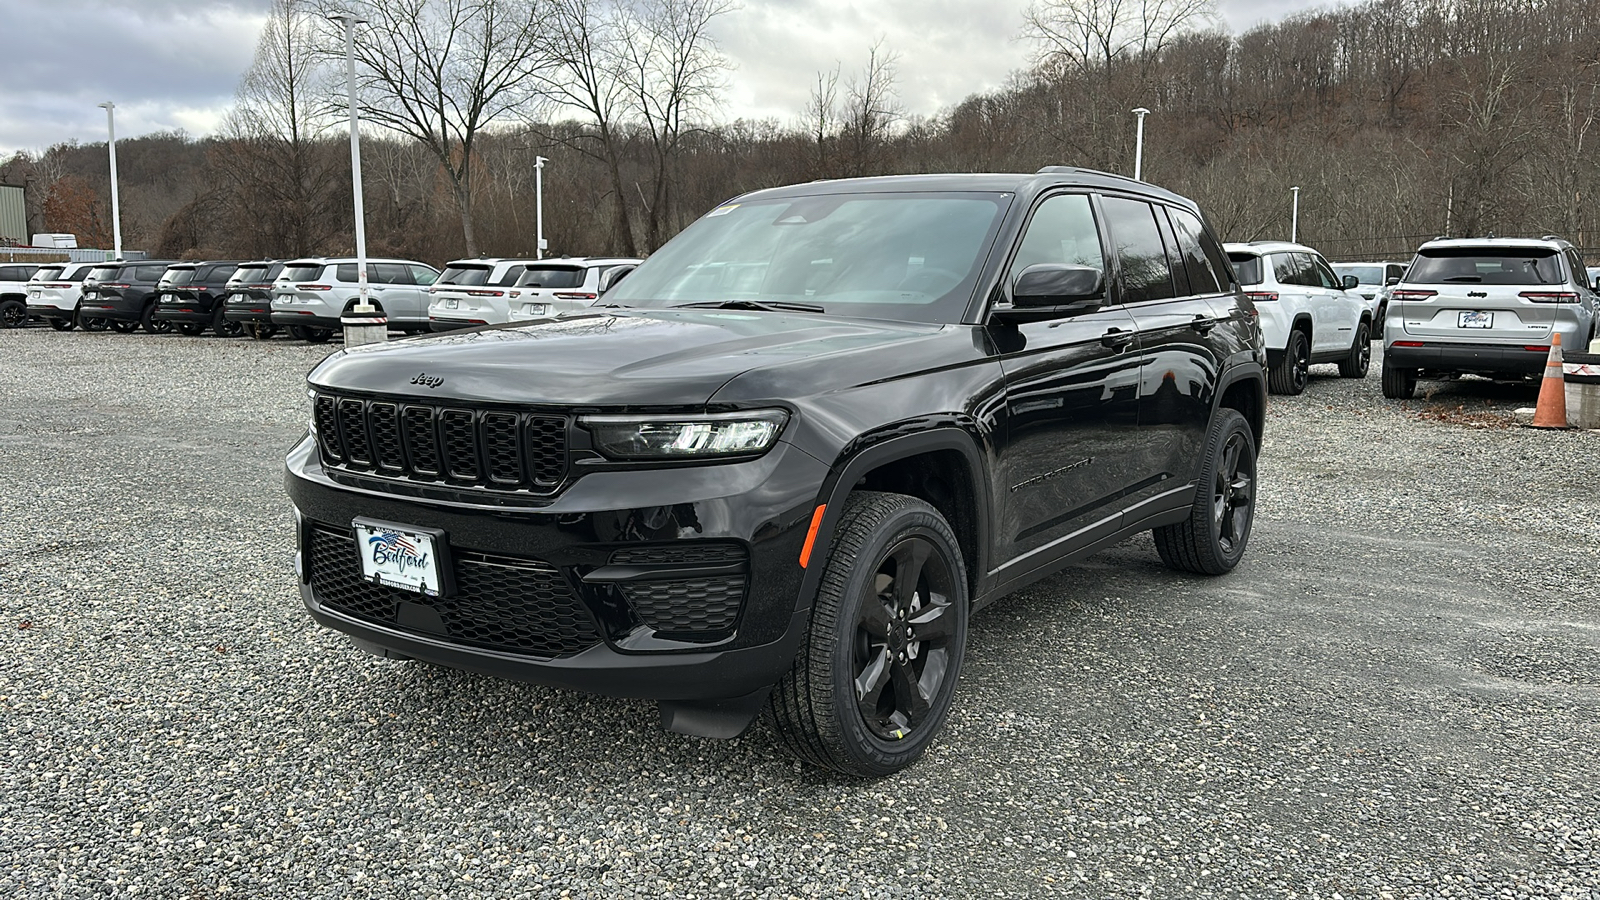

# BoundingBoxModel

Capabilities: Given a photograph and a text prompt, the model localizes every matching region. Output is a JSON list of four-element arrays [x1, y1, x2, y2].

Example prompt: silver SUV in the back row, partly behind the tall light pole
[[272, 256, 438, 343]]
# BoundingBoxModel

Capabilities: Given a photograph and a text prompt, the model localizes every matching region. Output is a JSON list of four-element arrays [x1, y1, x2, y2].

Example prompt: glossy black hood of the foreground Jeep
[[307, 309, 941, 407]]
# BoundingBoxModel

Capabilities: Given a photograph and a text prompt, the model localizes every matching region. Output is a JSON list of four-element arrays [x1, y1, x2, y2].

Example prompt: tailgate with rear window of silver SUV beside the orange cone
[[1402, 247, 1578, 346]]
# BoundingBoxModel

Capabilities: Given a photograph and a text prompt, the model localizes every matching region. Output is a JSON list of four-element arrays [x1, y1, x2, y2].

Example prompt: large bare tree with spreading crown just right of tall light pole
[[322, 0, 549, 255]]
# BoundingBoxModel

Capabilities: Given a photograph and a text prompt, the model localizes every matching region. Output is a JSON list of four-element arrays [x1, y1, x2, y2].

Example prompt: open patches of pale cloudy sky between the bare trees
[[0, 0, 1328, 155]]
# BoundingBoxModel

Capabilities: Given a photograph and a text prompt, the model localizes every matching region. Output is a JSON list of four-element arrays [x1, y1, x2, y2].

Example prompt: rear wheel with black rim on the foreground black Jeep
[[1150, 408, 1256, 575]]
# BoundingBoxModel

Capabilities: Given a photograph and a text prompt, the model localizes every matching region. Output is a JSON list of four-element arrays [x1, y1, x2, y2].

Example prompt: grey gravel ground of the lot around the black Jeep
[[0, 327, 1600, 898]]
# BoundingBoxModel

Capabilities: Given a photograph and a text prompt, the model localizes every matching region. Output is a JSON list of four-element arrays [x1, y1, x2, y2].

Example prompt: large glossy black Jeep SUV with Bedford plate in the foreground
[[286, 168, 1266, 775]]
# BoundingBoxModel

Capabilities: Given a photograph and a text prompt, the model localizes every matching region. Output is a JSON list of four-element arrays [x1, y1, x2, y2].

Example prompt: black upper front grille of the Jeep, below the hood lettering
[[312, 392, 568, 495]]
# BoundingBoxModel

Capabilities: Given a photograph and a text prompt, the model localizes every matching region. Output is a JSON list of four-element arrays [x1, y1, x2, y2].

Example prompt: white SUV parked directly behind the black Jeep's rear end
[[1224, 240, 1373, 394]]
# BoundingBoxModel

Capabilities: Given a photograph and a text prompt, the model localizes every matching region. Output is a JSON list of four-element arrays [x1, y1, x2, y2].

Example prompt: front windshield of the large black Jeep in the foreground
[[605, 192, 1011, 323]]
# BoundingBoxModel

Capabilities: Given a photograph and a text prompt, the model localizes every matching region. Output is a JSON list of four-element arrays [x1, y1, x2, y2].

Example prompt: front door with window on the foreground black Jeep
[[994, 194, 1139, 566]]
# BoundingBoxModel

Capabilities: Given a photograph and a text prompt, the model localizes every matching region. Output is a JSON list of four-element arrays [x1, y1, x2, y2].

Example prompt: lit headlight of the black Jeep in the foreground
[[579, 410, 789, 460]]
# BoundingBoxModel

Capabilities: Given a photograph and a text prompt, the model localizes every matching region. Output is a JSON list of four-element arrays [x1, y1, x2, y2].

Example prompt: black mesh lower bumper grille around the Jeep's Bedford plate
[[307, 525, 600, 657]]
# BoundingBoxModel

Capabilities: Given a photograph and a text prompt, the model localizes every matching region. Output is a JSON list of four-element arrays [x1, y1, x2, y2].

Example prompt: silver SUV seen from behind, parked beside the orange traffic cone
[[1384, 237, 1597, 400]]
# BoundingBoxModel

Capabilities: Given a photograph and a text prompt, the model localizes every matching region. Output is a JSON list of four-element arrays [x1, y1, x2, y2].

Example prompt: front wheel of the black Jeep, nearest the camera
[[766, 492, 968, 777]]
